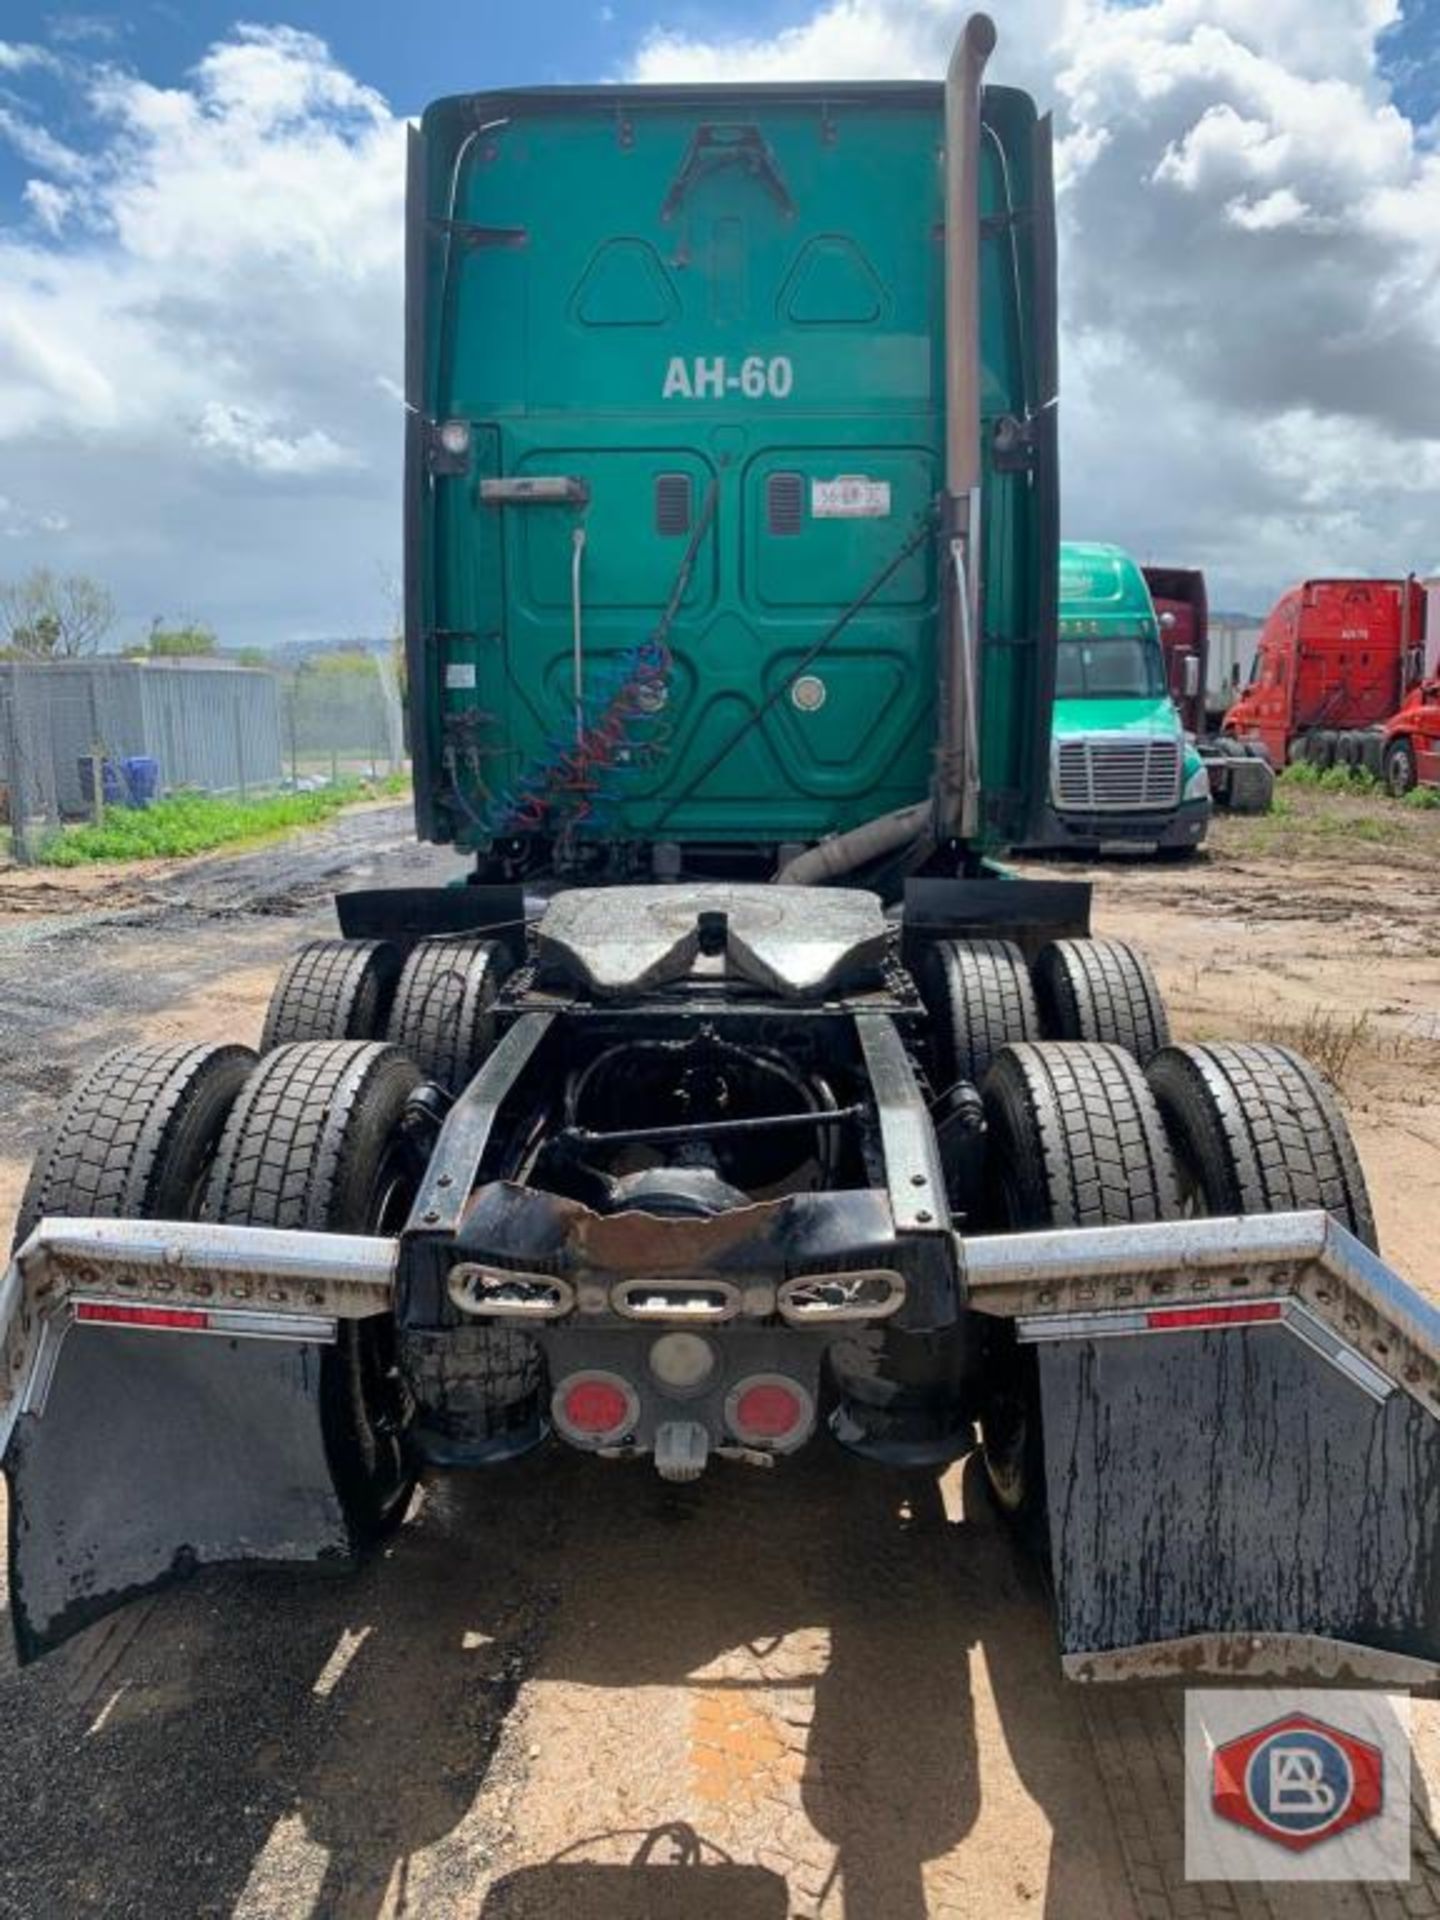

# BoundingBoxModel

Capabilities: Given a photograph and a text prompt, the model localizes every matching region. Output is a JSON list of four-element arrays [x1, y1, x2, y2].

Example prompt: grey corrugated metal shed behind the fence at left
[[0, 659, 282, 820]]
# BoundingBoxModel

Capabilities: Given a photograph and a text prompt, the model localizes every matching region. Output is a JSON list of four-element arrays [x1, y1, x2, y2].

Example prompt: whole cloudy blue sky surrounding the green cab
[[0, 0, 1440, 643]]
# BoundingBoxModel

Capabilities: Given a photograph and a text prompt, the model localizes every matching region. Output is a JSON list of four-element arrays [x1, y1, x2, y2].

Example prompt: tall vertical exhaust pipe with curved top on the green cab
[[933, 13, 996, 839]]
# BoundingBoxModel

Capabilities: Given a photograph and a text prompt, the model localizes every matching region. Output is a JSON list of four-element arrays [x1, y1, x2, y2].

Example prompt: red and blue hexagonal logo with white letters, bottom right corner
[[1210, 1713, 1384, 1853]]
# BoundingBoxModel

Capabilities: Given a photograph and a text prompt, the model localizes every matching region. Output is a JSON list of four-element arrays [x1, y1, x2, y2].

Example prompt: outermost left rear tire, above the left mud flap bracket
[[13, 1044, 255, 1246]]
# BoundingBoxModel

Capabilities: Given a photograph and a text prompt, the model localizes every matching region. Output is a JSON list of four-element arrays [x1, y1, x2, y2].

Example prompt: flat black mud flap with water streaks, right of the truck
[[1037, 1323, 1440, 1684]]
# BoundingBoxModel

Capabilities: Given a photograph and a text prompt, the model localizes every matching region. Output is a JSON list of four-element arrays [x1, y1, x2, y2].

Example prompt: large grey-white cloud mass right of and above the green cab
[[628, 0, 1440, 607]]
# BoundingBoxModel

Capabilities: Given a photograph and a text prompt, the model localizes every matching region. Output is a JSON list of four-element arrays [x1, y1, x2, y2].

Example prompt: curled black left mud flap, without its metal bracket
[[4, 1325, 355, 1661]]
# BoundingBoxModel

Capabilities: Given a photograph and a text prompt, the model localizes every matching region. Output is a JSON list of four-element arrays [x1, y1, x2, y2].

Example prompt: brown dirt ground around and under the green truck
[[0, 799, 1440, 1920]]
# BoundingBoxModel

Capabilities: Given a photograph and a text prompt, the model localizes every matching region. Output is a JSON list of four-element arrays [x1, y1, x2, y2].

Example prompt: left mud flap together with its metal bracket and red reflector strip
[[0, 1219, 409, 1661]]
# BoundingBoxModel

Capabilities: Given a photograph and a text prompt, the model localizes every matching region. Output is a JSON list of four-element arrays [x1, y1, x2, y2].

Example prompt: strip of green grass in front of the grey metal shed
[[38, 776, 389, 866]]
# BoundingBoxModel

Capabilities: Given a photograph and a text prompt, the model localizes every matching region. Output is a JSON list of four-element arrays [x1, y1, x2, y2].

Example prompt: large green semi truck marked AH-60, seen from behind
[[0, 15, 1440, 1684]]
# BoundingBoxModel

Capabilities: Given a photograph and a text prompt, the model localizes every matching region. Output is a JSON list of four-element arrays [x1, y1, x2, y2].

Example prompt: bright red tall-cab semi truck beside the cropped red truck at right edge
[[1223, 574, 1425, 778]]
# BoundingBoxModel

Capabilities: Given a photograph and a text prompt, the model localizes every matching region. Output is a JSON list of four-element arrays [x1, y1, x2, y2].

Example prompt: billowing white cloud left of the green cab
[[0, 27, 405, 643]]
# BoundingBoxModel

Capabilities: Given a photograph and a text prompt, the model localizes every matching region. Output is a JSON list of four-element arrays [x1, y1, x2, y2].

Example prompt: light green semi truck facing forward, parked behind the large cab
[[1039, 540, 1212, 858]]
